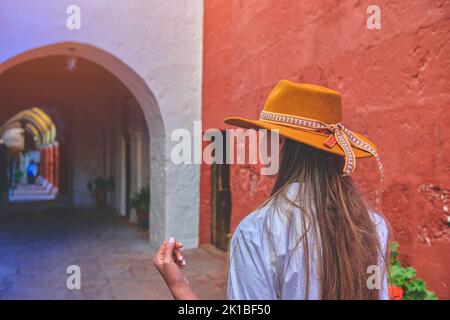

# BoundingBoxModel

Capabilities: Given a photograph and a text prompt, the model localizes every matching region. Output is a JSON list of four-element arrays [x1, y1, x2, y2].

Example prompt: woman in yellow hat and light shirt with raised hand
[[153, 80, 388, 300]]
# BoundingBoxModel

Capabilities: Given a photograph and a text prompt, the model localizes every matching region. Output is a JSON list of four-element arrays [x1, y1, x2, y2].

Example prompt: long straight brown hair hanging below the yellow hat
[[266, 139, 384, 299]]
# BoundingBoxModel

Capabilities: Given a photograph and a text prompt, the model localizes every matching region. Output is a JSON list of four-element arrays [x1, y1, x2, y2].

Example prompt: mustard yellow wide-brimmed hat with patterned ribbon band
[[225, 80, 383, 179]]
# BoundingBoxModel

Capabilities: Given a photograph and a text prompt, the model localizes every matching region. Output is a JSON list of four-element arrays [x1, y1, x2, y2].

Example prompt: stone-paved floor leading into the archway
[[0, 203, 226, 299]]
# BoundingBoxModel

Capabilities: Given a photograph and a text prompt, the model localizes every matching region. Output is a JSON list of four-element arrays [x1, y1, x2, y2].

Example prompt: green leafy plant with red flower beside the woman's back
[[389, 242, 437, 300]]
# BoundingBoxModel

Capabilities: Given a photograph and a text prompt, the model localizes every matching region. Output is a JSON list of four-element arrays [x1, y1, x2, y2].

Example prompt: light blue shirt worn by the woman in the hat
[[227, 183, 388, 300]]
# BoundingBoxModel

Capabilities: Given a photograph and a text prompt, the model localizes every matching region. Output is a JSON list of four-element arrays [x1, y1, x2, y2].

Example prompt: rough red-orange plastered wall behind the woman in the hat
[[200, 0, 450, 298]]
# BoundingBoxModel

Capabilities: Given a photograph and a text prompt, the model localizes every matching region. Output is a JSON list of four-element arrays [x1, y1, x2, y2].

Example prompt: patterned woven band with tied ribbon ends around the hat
[[259, 111, 384, 181]]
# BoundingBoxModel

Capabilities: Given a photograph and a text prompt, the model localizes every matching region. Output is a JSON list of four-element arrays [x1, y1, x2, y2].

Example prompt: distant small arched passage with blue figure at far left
[[0, 107, 60, 202]]
